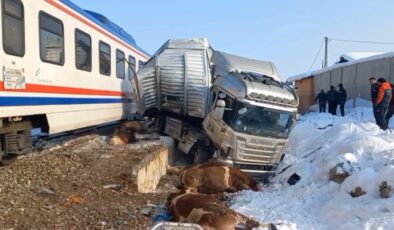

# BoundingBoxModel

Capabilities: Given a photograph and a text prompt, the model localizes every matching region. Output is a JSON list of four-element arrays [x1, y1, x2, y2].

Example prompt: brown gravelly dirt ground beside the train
[[0, 135, 176, 229]]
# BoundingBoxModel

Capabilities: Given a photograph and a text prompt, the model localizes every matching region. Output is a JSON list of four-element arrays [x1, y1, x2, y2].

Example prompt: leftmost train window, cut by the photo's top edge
[[2, 0, 25, 57]]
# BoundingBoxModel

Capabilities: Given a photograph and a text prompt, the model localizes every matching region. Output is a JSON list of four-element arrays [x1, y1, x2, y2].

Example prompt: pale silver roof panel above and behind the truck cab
[[211, 51, 281, 81]]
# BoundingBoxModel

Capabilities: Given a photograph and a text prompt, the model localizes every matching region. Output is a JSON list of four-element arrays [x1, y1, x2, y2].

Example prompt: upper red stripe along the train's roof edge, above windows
[[46, 0, 148, 59]]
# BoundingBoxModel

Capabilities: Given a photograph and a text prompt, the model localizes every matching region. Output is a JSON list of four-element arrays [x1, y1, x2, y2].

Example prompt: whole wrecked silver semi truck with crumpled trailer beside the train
[[134, 38, 299, 174]]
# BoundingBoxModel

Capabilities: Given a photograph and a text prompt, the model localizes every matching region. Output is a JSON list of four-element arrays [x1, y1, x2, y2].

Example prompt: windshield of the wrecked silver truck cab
[[231, 103, 293, 137]]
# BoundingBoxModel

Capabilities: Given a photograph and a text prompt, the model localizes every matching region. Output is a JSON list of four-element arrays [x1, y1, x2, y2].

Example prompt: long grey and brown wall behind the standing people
[[295, 57, 394, 111]]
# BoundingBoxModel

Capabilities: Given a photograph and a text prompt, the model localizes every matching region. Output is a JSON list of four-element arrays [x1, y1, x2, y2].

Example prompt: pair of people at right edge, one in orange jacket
[[369, 77, 394, 130]]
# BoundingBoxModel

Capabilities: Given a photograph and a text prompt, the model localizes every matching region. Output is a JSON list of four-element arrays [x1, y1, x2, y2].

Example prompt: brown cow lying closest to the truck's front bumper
[[179, 162, 259, 194]]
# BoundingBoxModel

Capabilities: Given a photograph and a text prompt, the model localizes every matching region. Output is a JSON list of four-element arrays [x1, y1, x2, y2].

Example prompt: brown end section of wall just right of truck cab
[[296, 77, 315, 112]]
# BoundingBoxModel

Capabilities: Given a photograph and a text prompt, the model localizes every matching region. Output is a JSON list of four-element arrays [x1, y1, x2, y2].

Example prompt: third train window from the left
[[75, 29, 92, 71]]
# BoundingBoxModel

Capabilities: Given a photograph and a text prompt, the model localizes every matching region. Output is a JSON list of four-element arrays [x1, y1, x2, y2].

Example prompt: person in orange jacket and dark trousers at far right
[[375, 78, 391, 130]]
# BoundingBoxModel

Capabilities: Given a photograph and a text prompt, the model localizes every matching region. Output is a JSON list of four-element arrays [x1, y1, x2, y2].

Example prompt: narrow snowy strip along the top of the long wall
[[287, 52, 394, 82]]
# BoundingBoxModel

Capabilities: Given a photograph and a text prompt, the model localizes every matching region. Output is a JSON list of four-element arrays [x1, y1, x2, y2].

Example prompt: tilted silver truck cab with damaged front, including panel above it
[[203, 52, 298, 174]]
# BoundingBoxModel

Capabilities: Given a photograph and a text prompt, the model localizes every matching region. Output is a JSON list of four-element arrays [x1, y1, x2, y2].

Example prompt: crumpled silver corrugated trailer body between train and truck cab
[[137, 38, 212, 118]]
